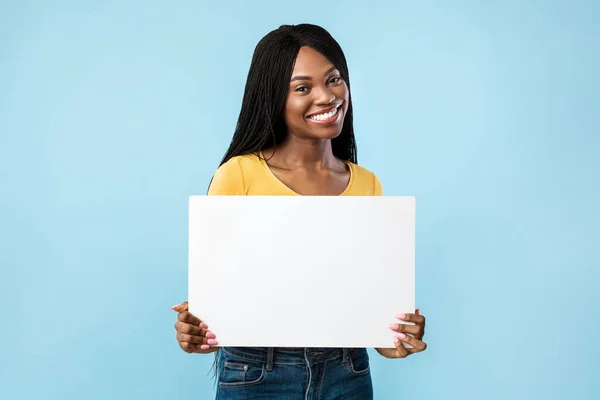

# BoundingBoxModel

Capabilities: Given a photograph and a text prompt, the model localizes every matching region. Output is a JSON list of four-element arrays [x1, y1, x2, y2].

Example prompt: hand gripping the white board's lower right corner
[[375, 310, 427, 358]]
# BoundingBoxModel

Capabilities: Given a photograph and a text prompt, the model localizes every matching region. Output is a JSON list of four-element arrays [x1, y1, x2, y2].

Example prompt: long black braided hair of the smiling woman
[[220, 24, 357, 165]]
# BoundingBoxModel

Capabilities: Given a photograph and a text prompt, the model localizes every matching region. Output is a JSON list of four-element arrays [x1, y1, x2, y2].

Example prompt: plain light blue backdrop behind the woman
[[0, 0, 600, 399]]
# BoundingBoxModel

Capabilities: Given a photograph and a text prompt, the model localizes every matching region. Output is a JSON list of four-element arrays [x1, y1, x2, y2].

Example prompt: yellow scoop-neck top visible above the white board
[[208, 154, 383, 196]]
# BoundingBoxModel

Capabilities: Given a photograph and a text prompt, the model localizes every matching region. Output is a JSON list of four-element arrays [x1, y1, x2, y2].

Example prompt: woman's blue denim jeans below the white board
[[216, 347, 373, 400]]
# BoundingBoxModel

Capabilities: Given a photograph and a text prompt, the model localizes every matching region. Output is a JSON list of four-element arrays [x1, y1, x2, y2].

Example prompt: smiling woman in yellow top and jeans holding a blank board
[[173, 24, 426, 399]]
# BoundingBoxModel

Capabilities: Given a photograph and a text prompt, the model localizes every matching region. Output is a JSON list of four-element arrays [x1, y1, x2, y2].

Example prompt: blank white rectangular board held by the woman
[[188, 196, 415, 348]]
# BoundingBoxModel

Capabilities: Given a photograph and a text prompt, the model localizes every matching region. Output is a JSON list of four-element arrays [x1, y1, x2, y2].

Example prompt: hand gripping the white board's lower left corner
[[171, 301, 219, 354]]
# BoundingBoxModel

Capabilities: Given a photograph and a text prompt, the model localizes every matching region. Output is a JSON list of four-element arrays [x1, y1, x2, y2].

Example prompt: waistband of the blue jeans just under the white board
[[221, 347, 366, 365]]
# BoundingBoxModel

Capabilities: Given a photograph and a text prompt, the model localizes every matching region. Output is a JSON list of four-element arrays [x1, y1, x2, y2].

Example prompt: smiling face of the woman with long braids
[[284, 47, 349, 139]]
